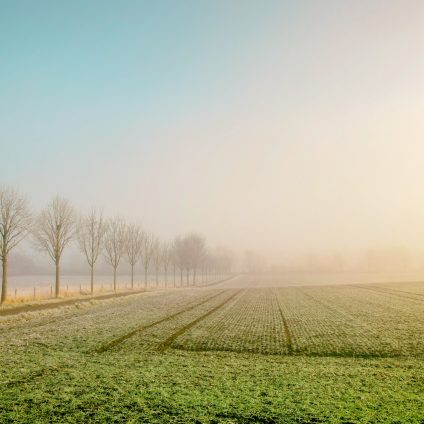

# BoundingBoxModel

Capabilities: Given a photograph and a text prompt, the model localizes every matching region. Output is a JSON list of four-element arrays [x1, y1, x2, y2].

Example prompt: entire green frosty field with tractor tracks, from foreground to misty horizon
[[0, 276, 424, 423]]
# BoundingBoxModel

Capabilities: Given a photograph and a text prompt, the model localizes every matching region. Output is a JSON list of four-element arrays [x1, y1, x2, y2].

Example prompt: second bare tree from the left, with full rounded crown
[[33, 196, 75, 297]]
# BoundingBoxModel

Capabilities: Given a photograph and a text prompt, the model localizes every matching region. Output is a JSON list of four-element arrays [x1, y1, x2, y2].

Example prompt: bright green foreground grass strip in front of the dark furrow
[[0, 351, 424, 423]]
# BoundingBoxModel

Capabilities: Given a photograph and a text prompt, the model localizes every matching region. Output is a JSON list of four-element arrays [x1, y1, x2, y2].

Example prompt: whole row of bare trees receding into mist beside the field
[[0, 187, 233, 303]]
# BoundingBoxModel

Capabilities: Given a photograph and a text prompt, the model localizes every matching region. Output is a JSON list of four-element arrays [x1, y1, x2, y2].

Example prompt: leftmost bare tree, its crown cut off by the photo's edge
[[0, 187, 31, 303]]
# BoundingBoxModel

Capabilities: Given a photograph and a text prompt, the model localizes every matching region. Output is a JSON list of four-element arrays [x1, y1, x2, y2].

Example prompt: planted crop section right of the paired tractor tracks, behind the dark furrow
[[173, 286, 424, 357]]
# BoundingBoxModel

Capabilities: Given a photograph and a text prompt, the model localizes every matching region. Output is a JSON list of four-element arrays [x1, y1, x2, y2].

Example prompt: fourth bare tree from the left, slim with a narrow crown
[[104, 217, 127, 291]]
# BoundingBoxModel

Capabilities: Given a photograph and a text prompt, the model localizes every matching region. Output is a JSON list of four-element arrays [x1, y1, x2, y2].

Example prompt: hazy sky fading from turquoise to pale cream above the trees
[[0, 0, 424, 268]]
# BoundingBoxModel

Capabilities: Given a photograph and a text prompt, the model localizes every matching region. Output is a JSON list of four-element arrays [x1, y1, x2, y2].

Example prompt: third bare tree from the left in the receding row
[[77, 209, 106, 294]]
